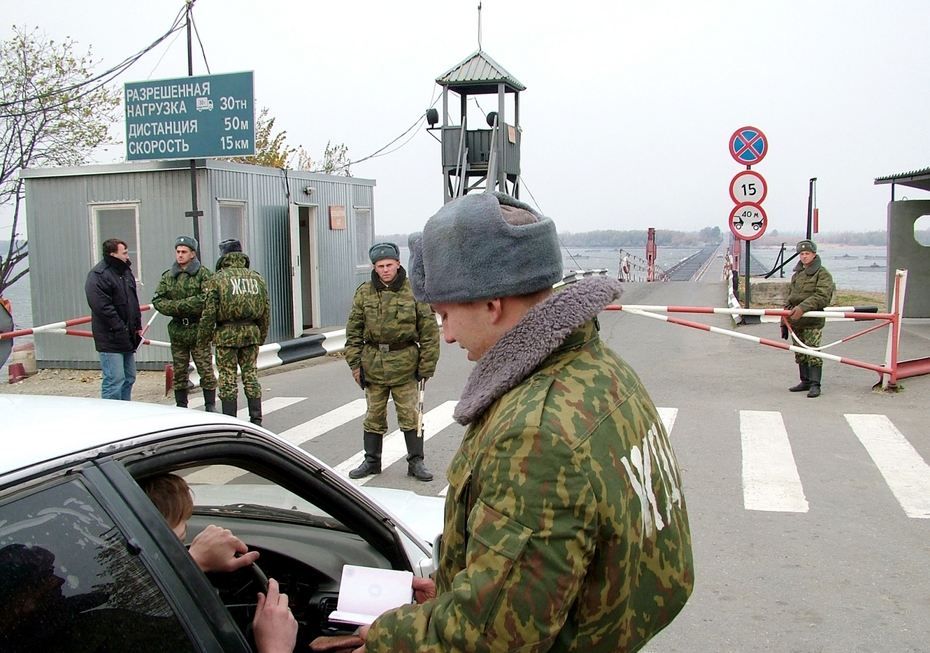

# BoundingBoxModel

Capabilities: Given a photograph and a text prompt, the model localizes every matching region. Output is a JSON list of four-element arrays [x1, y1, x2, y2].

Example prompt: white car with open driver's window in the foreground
[[0, 395, 443, 653]]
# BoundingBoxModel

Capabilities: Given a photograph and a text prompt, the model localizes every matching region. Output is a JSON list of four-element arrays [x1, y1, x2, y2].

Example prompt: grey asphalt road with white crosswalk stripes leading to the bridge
[[252, 266, 930, 653]]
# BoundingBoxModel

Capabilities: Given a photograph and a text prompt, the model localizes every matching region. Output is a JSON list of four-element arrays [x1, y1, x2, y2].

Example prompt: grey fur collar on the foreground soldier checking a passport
[[453, 277, 623, 424]]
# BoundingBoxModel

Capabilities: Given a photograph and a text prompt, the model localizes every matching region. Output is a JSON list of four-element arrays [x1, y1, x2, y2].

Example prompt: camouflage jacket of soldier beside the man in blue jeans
[[152, 258, 213, 347]]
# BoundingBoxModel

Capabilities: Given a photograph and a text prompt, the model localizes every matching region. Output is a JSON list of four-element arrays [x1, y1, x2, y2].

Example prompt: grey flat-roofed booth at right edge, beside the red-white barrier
[[875, 168, 930, 318]]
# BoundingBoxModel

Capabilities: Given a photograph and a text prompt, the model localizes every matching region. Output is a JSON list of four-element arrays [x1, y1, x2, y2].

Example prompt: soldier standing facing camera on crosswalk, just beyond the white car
[[345, 243, 439, 481]]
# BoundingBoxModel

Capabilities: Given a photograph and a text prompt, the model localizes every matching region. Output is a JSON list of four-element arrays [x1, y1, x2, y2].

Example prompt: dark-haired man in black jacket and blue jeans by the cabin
[[84, 238, 142, 401]]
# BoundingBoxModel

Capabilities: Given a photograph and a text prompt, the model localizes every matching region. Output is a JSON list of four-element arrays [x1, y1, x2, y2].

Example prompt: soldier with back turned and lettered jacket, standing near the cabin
[[200, 238, 271, 425]]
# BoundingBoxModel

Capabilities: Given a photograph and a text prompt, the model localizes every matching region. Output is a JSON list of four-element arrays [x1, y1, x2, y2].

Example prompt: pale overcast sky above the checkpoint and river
[[0, 0, 930, 236]]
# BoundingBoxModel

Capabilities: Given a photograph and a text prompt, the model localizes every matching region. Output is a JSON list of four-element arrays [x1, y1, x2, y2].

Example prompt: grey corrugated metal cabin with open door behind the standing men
[[22, 159, 375, 369]]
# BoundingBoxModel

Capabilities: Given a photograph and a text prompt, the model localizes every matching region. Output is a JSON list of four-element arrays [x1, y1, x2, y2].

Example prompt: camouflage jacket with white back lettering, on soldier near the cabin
[[200, 252, 271, 347]]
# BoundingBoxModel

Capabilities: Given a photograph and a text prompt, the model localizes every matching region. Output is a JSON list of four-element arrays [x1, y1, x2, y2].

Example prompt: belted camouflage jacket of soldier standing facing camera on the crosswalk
[[345, 267, 439, 385]]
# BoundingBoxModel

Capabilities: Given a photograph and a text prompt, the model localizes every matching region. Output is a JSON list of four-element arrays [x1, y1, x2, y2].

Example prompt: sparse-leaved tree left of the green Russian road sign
[[0, 27, 120, 296]]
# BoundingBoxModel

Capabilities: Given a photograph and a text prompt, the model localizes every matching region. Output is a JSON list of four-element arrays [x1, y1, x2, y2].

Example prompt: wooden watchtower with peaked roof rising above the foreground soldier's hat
[[427, 48, 526, 202]]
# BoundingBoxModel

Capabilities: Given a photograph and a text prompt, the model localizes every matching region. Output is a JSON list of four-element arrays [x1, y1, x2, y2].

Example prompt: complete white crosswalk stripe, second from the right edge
[[739, 410, 809, 512]]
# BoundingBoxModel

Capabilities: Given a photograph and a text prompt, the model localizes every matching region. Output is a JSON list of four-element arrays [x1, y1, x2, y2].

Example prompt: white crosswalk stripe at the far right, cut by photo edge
[[844, 415, 930, 519]]
